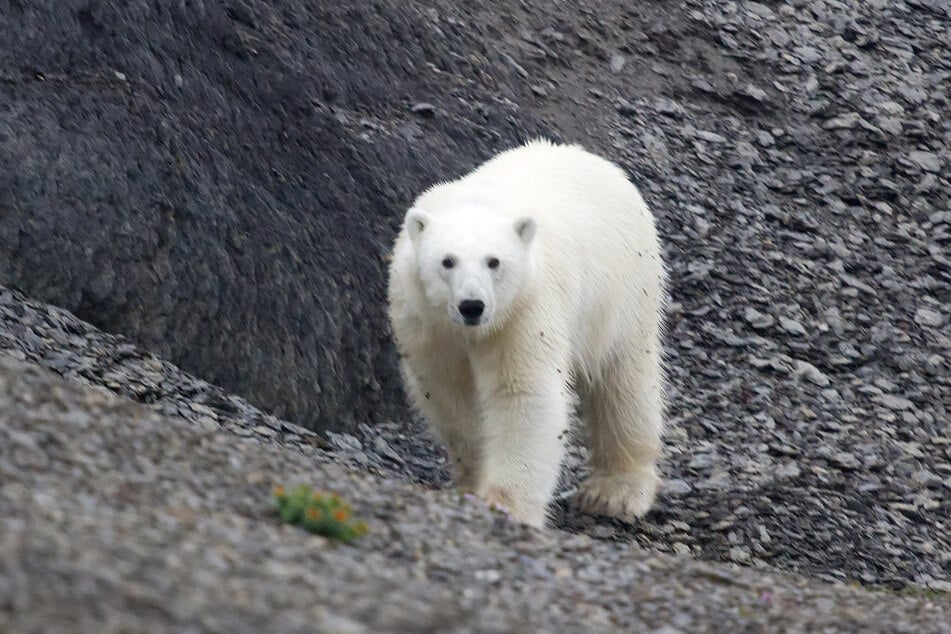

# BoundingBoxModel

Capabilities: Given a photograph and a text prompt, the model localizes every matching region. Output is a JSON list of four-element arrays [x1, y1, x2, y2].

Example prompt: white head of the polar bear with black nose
[[405, 206, 535, 327]]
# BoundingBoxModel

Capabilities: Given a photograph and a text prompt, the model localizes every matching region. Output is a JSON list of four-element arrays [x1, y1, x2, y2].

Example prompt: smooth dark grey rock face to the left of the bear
[[0, 0, 538, 428]]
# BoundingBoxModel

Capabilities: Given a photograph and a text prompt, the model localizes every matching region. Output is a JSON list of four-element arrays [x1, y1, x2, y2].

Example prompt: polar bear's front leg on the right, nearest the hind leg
[[475, 344, 570, 528]]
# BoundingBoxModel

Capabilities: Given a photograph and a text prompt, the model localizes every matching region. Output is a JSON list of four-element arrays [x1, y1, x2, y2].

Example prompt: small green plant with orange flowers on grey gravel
[[274, 484, 368, 543]]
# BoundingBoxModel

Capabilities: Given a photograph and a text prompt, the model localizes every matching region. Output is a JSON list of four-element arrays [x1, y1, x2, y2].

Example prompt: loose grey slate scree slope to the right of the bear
[[436, 0, 951, 591]]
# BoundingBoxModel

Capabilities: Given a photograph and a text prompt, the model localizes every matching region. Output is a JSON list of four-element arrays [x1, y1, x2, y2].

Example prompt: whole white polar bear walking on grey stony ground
[[388, 140, 666, 527]]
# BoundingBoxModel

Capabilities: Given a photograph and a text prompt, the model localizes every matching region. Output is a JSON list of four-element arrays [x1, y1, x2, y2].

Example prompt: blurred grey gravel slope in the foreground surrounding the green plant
[[0, 353, 951, 632]]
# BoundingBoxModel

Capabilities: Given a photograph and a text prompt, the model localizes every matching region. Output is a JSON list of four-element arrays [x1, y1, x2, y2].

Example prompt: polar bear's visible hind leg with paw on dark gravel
[[577, 352, 664, 521]]
